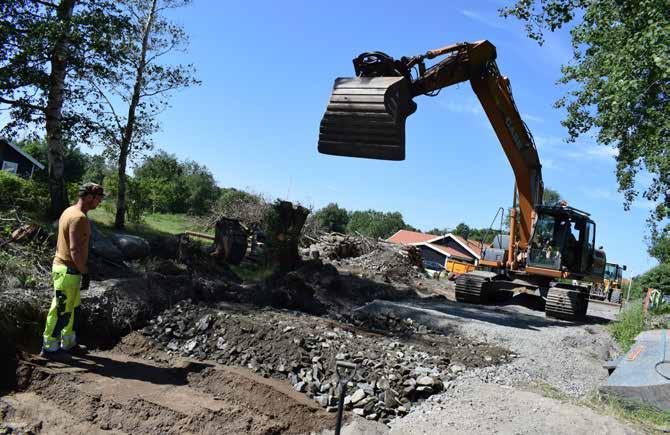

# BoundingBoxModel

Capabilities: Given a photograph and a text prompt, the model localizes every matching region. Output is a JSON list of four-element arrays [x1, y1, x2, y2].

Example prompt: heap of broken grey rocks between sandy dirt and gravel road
[[142, 302, 509, 422]]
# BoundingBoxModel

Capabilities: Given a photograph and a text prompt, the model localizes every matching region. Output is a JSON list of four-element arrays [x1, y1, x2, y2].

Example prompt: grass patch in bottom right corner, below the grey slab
[[584, 394, 670, 433]]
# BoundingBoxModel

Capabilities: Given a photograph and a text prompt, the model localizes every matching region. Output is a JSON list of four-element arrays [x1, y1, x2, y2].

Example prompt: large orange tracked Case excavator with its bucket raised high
[[318, 40, 606, 320]]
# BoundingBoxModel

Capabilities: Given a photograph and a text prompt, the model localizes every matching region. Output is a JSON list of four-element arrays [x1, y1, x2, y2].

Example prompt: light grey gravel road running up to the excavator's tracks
[[358, 296, 636, 434]]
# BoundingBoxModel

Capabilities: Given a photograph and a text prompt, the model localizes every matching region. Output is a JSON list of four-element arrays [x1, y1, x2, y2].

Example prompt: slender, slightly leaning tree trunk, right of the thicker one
[[114, 0, 158, 229]]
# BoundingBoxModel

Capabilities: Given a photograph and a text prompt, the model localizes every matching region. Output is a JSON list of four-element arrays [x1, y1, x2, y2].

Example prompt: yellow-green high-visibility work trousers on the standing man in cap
[[42, 265, 81, 352]]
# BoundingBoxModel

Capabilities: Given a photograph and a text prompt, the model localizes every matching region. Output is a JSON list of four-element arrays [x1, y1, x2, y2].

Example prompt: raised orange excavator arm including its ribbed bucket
[[319, 41, 543, 254]]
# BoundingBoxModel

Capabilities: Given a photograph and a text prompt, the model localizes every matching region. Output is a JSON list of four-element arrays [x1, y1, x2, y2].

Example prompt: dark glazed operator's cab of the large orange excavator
[[527, 206, 605, 277]]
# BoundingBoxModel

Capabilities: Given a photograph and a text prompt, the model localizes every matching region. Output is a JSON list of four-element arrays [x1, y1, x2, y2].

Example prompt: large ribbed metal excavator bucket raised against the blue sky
[[319, 77, 416, 160]]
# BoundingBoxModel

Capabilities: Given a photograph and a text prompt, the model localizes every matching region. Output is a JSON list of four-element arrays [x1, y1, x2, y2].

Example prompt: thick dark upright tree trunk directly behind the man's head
[[45, 0, 76, 217]]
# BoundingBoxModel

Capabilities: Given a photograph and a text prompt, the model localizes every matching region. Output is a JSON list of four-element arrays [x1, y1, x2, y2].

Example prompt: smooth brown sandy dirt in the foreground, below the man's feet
[[0, 334, 342, 434]]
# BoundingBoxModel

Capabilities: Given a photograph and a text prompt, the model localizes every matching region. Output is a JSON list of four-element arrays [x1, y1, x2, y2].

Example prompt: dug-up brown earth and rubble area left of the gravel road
[[0, 264, 510, 434]]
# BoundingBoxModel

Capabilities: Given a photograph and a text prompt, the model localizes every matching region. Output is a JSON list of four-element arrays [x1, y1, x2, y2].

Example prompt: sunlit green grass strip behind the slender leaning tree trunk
[[88, 208, 214, 237]]
